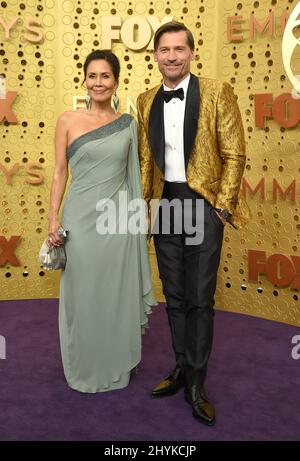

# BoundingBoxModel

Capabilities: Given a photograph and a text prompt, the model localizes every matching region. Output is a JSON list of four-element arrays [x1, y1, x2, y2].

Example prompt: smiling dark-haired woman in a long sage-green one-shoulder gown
[[48, 50, 155, 392]]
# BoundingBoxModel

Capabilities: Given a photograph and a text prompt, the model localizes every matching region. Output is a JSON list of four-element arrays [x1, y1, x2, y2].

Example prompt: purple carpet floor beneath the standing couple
[[0, 300, 300, 441]]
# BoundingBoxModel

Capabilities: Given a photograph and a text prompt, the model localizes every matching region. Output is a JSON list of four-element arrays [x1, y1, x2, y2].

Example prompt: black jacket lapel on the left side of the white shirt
[[149, 86, 165, 173]]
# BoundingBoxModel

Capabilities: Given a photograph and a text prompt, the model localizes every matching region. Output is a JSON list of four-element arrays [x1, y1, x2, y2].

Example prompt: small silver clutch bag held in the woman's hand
[[39, 227, 69, 270]]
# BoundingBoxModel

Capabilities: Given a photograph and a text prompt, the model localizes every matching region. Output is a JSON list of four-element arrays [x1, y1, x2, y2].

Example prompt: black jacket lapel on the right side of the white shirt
[[183, 74, 200, 170]]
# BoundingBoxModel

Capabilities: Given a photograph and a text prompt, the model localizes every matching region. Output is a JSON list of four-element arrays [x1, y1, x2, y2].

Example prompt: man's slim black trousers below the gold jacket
[[154, 182, 224, 387]]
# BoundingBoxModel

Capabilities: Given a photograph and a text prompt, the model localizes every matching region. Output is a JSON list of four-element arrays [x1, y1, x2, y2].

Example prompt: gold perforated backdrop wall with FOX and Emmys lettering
[[0, 0, 300, 325]]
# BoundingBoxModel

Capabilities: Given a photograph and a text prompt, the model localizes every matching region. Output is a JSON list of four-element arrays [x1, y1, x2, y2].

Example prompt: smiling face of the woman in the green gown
[[85, 59, 118, 103]]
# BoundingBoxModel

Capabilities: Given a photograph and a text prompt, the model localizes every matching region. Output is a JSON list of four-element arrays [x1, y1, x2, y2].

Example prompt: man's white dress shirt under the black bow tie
[[164, 74, 191, 182]]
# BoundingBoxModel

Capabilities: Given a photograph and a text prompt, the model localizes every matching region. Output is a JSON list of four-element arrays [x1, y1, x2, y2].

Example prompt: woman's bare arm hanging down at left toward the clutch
[[48, 113, 69, 245]]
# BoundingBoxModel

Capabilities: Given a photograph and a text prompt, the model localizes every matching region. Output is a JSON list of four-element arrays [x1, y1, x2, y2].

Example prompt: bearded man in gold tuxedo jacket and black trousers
[[137, 22, 249, 425]]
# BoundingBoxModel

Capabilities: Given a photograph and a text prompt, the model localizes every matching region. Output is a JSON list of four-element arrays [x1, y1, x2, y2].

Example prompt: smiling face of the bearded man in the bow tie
[[154, 30, 194, 87]]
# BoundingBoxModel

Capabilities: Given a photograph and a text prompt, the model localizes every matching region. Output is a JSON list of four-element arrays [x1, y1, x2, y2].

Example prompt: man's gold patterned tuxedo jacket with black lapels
[[137, 74, 250, 228]]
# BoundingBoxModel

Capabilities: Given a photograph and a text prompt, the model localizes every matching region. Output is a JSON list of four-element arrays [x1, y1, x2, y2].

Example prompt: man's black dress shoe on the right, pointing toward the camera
[[184, 385, 216, 426]]
